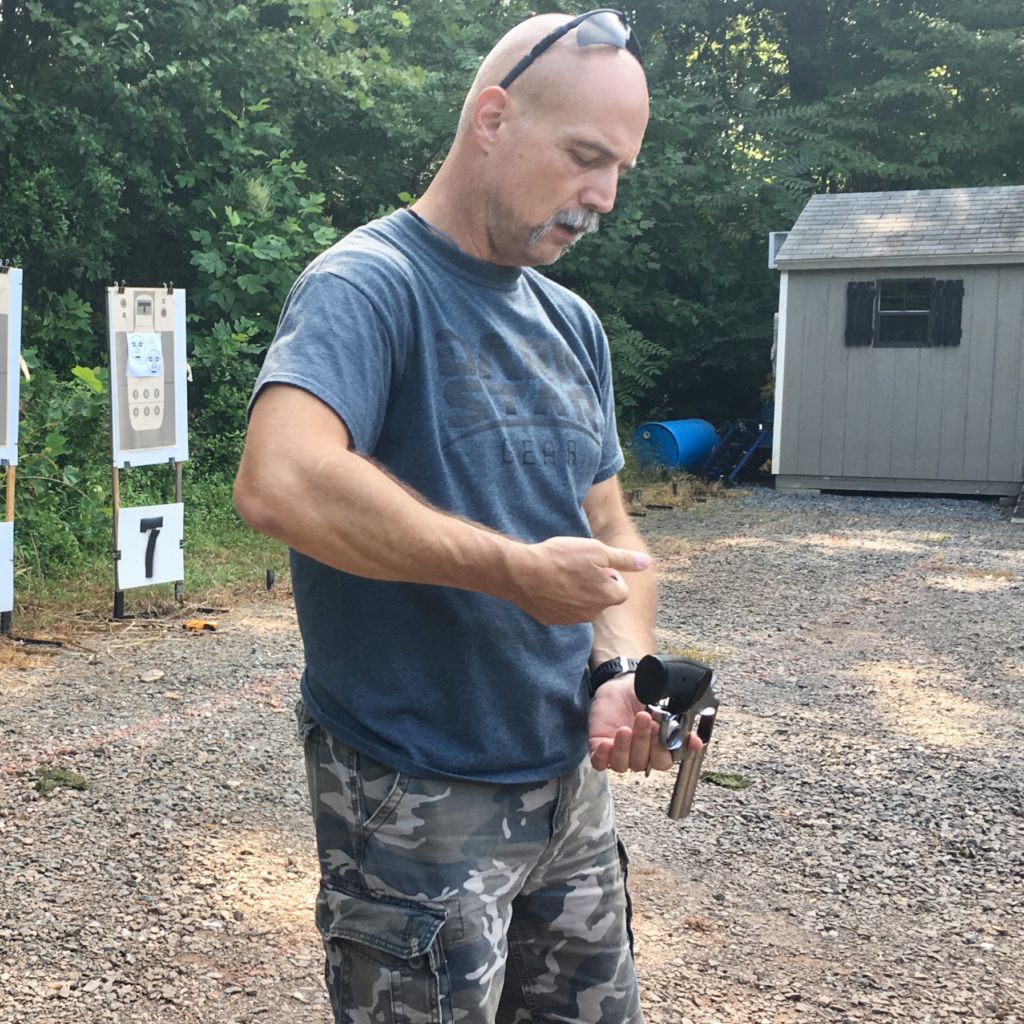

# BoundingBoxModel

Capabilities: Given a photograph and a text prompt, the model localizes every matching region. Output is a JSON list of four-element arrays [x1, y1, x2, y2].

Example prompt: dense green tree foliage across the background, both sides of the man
[[0, 0, 1024, 558]]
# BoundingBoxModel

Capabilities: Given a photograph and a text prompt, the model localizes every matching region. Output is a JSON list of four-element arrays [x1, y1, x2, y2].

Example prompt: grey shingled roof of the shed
[[776, 185, 1024, 270]]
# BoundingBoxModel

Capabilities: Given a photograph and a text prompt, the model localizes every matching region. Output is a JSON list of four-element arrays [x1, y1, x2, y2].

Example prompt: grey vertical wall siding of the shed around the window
[[777, 265, 1024, 481]]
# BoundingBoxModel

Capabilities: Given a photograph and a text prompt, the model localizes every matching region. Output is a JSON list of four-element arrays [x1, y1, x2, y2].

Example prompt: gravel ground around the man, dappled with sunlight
[[0, 490, 1024, 1024]]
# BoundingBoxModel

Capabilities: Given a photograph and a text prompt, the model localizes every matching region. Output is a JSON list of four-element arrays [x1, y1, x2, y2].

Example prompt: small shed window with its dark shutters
[[846, 278, 964, 348]]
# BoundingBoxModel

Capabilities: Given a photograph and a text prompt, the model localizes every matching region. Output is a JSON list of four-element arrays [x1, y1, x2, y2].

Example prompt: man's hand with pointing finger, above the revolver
[[508, 537, 650, 626]]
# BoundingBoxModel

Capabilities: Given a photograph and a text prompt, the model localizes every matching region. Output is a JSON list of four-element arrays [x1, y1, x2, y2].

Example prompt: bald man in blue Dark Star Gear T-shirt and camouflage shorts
[[236, 11, 692, 1024]]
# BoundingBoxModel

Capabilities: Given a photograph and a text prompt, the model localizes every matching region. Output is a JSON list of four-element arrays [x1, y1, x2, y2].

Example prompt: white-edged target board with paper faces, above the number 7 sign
[[106, 288, 188, 468]]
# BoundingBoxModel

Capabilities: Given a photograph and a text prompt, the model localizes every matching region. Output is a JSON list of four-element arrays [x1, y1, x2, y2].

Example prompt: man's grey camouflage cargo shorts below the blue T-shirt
[[296, 701, 643, 1024]]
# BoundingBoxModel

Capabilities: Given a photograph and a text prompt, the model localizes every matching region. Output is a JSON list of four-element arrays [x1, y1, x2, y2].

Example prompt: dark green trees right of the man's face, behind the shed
[[553, 0, 1024, 422]]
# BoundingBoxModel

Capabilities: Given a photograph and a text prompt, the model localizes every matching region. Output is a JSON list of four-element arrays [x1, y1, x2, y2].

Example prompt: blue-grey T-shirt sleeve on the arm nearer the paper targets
[[249, 267, 394, 455]]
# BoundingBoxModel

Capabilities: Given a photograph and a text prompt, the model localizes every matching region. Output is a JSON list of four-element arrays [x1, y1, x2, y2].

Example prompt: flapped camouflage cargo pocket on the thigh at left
[[316, 886, 453, 1024]]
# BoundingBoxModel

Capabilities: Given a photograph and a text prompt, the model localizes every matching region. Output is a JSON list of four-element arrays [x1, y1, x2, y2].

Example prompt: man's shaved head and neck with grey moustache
[[415, 14, 648, 266]]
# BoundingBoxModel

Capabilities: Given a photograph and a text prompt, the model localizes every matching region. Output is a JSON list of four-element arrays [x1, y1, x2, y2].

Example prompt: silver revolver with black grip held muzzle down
[[633, 654, 718, 821]]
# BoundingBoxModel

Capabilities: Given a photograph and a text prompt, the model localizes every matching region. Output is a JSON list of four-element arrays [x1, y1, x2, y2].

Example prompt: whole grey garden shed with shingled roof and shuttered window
[[772, 185, 1024, 497]]
